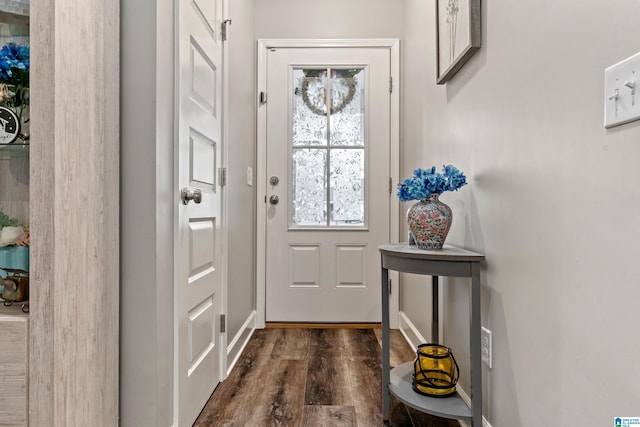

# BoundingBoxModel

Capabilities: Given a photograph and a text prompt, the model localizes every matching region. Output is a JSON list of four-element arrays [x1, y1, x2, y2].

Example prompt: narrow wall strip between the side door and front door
[[226, 0, 256, 360]]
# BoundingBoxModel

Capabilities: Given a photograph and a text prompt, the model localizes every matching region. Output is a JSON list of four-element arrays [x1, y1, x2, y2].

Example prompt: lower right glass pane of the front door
[[330, 149, 364, 225]]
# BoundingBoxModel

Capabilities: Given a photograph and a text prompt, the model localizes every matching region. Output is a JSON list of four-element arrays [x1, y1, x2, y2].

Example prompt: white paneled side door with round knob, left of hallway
[[175, 0, 224, 427]]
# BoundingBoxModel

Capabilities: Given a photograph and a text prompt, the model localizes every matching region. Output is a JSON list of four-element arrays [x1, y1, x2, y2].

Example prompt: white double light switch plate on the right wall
[[604, 53, 640, 128]]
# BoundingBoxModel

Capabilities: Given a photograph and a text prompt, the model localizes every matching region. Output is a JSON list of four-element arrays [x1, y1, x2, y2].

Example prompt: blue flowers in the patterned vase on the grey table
[[398, 165, 467, 202]]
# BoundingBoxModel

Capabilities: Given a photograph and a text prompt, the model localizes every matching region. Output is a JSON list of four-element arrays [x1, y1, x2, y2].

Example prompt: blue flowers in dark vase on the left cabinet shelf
[[0, 42, 30, 107]]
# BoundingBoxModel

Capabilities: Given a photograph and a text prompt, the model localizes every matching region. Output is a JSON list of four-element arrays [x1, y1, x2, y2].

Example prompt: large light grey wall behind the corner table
[[402, 0, 640, 427]]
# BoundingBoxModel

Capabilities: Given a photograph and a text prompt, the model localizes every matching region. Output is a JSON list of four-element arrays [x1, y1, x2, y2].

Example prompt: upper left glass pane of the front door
[[292, 69, 327, 145]]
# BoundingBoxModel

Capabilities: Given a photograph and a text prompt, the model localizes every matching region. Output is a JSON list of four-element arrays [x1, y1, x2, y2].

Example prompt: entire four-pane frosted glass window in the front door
[[290, 68, 367, 227]]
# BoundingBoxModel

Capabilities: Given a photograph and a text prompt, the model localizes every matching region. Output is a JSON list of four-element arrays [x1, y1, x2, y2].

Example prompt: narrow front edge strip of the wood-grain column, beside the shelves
[[28, 0, 55, 426]]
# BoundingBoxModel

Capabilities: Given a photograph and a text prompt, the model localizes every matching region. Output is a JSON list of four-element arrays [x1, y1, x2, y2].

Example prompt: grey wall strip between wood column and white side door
[[120, 0, 175, 427]]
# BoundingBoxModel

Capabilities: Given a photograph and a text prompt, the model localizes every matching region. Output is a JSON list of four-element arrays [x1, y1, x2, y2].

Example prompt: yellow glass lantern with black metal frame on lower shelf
[[412, 344, 459, 397]]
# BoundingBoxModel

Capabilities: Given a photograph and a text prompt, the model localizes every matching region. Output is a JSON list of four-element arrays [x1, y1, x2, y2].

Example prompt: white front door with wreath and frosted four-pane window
[[265, 48, 391, 322]]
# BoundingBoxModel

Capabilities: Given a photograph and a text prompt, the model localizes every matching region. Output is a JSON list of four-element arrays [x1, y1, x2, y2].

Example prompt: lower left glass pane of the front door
[[291, 148, 327, 225]]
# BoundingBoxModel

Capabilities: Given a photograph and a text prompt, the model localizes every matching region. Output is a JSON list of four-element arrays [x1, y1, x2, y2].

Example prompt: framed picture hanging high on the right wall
[[436, 0, 482, 84]]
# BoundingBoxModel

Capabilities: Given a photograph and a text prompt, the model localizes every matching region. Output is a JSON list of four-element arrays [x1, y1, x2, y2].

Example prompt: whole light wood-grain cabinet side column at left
[[29, 0, 120, 427]]
